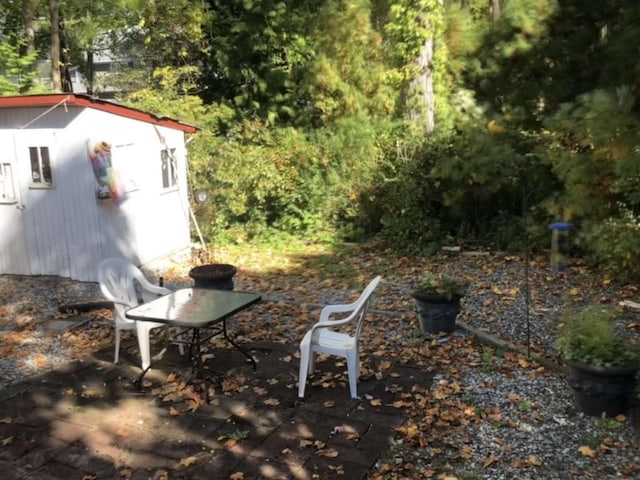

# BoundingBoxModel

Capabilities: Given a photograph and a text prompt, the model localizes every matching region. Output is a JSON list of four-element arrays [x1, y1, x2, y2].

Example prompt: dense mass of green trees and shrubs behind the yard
[[115, 0, 640, 279]]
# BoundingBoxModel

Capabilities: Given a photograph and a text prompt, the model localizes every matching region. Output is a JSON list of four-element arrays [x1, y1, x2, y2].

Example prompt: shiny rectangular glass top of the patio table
[[126, 288, 261, 327]]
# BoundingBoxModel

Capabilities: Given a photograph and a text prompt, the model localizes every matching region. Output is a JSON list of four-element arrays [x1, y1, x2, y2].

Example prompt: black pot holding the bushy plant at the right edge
[[565, 360, 639, 417]]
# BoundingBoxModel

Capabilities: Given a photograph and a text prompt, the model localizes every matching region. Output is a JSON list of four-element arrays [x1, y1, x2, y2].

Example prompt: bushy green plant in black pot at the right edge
[[556, 305, 640, 417]]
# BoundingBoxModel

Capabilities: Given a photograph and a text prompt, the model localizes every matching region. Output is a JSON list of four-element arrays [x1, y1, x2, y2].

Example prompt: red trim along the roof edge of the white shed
[[0, 93, 199, 133]]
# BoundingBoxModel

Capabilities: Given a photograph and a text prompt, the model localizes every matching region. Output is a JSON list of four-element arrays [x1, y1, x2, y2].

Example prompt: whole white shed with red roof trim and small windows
[[0, 94, 197, 281]]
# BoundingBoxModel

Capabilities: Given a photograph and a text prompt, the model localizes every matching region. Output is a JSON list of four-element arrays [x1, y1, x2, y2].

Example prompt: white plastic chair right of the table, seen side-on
[[298, 276, 381, 398]]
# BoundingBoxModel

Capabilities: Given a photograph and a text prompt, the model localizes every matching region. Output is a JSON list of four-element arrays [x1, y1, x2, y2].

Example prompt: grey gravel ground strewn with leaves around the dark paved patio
[[0, 251, 640, 480]]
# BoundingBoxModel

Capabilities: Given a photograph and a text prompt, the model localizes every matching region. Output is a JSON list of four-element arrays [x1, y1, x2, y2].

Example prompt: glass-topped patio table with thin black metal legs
[[125, 288, 261, 391]]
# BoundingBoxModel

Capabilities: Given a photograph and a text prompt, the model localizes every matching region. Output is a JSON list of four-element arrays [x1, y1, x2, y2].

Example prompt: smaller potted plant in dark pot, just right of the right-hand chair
[[411, 272, 469, 333]]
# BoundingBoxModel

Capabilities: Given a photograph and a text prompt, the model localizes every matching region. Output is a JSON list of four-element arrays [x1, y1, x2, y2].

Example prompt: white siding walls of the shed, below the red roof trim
[[0, 102, 190, 281]]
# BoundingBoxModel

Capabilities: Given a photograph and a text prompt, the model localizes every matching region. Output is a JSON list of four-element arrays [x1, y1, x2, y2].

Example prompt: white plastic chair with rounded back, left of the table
[[98, 258, 184, 372]]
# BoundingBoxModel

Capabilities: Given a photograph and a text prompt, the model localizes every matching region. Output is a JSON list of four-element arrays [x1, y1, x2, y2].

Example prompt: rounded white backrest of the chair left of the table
[[98, 258, 143, 314]]
